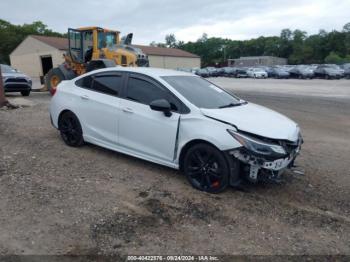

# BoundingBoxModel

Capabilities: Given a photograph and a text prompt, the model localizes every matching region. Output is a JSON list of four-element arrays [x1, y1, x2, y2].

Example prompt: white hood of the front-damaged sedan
[[201, 103, 299, 141]]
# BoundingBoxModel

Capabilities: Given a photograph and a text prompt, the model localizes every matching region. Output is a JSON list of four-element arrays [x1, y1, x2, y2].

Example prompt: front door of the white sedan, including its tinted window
[[118, 73, 180, 161]]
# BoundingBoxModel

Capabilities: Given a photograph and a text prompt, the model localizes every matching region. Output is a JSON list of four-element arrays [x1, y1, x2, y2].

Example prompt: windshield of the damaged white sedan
[[162, 76, 241, 109]]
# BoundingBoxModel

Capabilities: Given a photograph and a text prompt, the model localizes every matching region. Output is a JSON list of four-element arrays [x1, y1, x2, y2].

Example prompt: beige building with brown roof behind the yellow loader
[[10, 35, 201, 78]]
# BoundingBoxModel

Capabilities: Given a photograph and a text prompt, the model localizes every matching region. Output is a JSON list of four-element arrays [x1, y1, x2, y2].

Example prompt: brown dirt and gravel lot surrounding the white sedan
[[0, 78, 350, 255]]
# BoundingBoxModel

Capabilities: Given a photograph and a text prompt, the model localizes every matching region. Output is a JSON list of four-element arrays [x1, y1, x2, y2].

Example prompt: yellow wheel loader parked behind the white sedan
[[44, 27, 149, 94]]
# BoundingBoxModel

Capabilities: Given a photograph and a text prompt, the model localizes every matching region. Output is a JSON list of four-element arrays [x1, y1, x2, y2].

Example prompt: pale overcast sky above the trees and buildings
[[0, 0, 350, 44]]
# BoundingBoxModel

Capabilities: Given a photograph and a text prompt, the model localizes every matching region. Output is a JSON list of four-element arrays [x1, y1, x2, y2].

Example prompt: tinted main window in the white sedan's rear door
[[92, 75, 122, 96]]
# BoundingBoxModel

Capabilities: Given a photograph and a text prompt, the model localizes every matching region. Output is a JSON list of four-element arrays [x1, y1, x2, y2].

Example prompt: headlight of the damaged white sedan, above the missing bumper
[[227, 129, 287, 157]]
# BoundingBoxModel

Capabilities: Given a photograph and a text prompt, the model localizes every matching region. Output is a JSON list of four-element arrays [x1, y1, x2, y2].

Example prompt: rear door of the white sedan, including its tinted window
[[76, 72, 124, 145]]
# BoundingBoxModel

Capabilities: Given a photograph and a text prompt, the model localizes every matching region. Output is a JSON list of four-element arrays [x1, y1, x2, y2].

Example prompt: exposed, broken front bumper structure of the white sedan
[[229, 144, 301, 182]]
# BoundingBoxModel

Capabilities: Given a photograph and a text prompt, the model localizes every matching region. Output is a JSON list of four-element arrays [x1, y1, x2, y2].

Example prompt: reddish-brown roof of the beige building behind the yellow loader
[[31, 35, 199, 58]]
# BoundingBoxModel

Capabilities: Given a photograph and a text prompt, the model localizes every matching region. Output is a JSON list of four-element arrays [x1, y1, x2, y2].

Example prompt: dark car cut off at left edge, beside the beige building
[[0, 65, 32, 96]]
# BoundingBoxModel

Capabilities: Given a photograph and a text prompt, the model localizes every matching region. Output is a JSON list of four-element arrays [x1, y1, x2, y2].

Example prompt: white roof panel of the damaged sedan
[[85, 66, 194, 77]]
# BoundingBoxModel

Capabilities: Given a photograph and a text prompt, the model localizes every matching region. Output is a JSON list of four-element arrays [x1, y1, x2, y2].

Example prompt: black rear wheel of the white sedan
[[58, 112, 84, 147]]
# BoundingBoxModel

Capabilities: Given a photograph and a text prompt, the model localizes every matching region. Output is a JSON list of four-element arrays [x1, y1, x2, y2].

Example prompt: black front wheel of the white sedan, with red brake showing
[[183, 143, 229, 193]]
